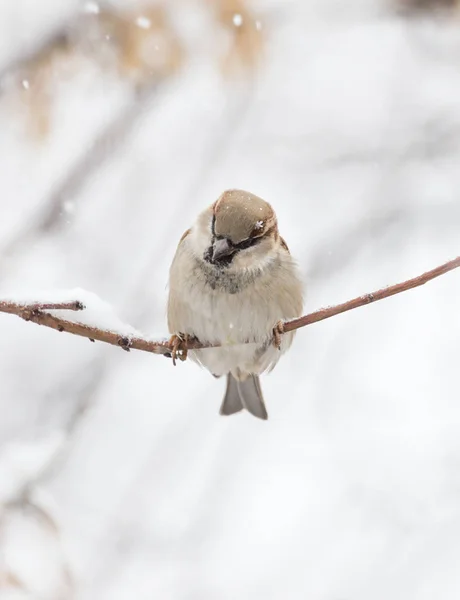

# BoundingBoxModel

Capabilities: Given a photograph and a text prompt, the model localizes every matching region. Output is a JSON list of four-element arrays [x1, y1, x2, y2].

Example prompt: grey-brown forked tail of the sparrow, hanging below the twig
[[220, 373, 268, 420]]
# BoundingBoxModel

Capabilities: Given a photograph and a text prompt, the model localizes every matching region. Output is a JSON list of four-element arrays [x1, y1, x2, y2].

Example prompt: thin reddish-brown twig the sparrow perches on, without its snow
[[0, 256, 460, 356]]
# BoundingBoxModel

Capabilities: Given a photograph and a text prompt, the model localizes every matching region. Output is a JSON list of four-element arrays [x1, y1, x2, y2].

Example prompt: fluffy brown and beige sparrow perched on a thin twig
[[167, 189, 304, 420]]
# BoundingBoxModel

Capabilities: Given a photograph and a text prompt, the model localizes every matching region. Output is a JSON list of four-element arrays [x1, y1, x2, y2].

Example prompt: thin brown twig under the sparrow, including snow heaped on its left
[[0, 256, 460, 356]]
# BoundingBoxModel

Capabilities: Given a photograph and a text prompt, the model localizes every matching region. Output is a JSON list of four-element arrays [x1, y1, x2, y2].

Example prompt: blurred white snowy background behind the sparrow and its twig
[[0, 0, 460, 600]]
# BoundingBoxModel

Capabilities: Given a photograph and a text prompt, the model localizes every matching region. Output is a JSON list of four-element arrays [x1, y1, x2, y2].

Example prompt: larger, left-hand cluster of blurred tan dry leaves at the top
[[4, 5, 184, 141]]
